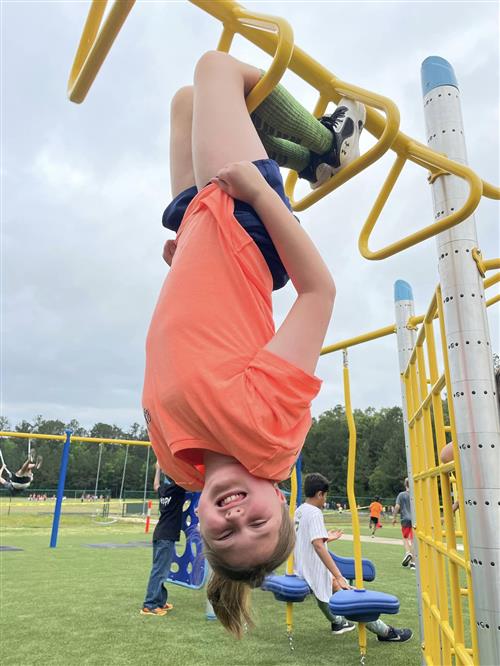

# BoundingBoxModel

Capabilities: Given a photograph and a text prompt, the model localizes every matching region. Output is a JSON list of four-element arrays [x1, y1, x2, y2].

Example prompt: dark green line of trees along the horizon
[[0, 405, 407, 498]]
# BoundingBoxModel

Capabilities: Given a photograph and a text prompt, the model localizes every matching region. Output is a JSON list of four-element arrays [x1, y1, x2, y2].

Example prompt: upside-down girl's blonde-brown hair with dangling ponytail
[[204, 503, 295, 638]]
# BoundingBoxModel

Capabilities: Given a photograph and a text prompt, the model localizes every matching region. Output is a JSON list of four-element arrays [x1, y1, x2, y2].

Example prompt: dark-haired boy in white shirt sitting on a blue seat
[[294, 474, 413, 643]]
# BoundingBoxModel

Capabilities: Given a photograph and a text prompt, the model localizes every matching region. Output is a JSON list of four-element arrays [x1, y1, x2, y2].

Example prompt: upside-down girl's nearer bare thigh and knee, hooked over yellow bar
[[193, 51, 267, 189]]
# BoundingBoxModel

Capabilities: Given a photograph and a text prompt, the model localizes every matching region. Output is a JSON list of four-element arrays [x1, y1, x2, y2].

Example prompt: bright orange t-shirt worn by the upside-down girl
[[143, 184, 321, 489]]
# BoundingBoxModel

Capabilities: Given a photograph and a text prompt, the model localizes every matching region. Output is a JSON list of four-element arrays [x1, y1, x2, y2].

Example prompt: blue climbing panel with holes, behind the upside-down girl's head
[[167, 493, 207, 590]]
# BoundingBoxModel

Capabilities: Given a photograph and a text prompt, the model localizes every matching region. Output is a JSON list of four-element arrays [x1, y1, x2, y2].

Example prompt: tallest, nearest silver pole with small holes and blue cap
[[422, 56, 500, 666]]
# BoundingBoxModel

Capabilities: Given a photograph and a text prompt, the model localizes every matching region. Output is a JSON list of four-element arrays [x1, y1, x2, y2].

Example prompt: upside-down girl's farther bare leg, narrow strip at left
[[170, 86, 195, 197]]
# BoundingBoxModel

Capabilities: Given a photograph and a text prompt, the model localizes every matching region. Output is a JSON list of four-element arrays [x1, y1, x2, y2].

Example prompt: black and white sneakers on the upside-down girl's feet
[[299, 97, 366, 190]]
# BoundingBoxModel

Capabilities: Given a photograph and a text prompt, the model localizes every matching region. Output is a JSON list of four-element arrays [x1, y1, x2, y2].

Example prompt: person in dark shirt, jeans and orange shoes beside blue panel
[[141, 463, 186, 616]]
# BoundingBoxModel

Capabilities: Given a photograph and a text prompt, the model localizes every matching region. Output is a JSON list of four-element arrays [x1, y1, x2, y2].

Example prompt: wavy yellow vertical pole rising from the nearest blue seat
[[343, 349, 366, 660]]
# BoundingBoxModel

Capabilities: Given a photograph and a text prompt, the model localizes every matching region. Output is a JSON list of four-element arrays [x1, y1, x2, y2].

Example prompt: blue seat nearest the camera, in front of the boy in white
[[328, 590, 399, 622]]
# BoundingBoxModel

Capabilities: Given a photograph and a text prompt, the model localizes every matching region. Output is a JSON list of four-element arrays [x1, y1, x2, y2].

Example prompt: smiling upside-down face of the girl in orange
[[198, 459, 285, 569]]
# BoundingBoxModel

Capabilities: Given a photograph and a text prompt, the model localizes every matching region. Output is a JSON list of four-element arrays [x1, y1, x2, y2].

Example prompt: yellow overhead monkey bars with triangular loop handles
[[68, 0, 500, 259]]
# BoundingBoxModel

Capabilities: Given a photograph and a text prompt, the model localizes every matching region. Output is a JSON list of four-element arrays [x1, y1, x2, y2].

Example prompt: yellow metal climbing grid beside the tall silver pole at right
[[404, 287, 479, 666]]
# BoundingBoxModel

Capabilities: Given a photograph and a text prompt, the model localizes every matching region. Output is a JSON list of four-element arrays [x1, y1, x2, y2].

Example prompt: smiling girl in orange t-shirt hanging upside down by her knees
[[143, 52, 364, 636]]
